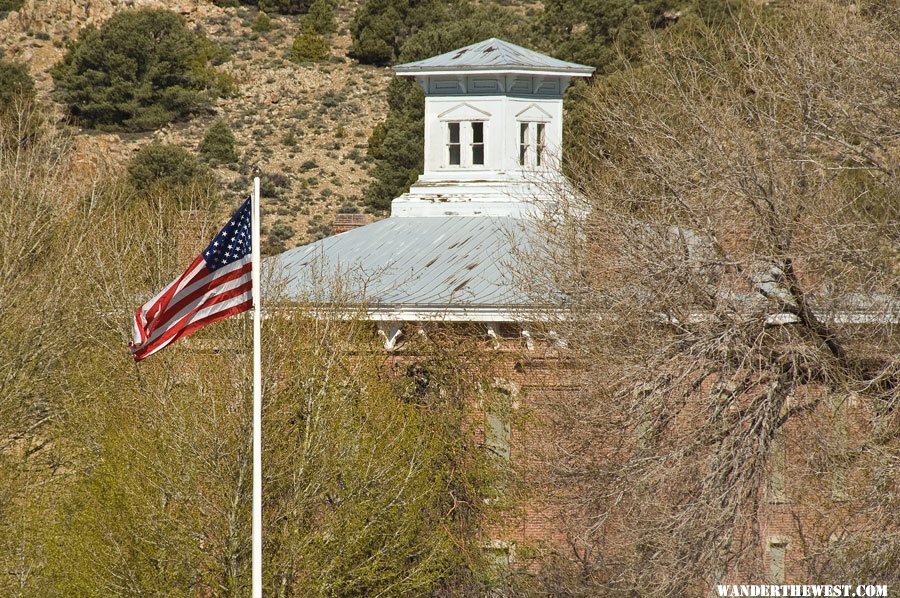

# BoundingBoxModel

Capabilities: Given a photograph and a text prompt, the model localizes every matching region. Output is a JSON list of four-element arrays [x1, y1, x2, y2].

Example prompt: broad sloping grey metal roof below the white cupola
[[266, 216, 535, 312]]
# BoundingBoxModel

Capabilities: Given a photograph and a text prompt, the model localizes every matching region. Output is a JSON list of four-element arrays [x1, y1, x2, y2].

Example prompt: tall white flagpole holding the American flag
[[250, 176, 262, 598]]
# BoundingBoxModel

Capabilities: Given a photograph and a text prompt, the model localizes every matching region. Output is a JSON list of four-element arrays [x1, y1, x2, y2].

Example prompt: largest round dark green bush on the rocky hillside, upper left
[[51, 9, 233, 131]]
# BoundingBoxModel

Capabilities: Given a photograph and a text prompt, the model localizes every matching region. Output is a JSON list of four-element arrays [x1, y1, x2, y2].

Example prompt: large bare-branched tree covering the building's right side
[[530, 0, 900, 596]]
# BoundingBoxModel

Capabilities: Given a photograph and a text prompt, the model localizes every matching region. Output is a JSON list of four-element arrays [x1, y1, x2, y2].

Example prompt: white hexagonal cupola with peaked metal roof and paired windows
[[391, 38, 594, 216]]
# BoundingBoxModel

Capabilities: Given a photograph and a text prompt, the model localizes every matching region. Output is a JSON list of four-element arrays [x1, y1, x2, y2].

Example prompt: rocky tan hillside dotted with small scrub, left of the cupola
[[0, 0, 392, 247]]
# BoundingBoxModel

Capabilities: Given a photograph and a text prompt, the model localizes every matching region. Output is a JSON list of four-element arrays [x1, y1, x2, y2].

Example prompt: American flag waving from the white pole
[[130, 197, 253, 361]]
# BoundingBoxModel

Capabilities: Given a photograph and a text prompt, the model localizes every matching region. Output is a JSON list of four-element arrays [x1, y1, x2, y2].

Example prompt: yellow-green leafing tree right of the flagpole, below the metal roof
[[263, 318, 506, 597]]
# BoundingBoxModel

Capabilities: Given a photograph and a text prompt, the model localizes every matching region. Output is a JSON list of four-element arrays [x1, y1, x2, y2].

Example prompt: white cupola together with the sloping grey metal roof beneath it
[[268, 39, 594, 324]]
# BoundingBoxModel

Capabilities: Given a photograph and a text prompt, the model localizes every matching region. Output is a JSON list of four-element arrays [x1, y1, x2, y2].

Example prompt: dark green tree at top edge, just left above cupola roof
[[349, 0, 454, 65]]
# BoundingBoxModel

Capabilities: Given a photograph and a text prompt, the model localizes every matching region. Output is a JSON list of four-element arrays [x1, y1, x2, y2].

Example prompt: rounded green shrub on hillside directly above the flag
[[127, 142, 208, 192]]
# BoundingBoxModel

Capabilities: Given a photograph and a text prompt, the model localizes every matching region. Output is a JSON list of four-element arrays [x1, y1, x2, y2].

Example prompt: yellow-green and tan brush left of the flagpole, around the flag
[[0, 113, 241, 598]]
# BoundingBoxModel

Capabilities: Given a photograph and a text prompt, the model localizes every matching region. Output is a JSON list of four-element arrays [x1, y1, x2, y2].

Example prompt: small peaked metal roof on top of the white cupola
[[394, 37, 594, 77]]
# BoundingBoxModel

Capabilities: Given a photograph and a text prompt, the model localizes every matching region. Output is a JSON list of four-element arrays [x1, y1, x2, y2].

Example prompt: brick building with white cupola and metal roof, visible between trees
[[269, 39, 892, 583]]
